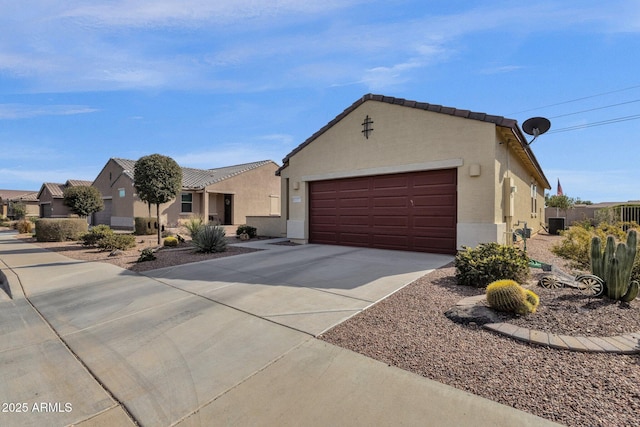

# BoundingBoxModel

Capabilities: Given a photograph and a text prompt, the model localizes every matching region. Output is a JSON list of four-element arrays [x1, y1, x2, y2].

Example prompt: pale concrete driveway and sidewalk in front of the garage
[[0, 233, 552, 426]]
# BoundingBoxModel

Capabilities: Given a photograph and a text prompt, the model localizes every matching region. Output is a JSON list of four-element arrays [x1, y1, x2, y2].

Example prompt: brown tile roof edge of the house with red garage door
[[276, 93, 551, 188]]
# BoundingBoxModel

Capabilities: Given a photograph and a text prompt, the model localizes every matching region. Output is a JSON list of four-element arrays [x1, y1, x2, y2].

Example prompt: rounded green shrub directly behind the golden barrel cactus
[[455, 243, 529, 288]]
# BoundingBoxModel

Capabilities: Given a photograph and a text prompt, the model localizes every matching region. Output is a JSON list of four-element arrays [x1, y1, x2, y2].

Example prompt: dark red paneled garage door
[[309, 169, 457, 254]]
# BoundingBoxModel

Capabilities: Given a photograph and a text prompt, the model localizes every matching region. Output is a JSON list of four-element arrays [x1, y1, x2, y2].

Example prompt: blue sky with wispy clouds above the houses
[[0, 0, 640, 202]]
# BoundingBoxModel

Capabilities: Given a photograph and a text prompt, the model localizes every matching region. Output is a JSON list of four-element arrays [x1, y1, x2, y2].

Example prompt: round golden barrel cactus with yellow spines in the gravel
[[487, 280, 540, 314]]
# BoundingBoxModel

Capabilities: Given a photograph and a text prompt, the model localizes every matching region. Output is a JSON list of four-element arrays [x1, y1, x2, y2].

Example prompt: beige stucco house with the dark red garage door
[[277, 94, 551, 254]]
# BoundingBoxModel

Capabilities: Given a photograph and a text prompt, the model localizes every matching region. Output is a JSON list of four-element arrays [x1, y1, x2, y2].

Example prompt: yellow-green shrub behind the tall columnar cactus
[[551, 221, 640, 270]]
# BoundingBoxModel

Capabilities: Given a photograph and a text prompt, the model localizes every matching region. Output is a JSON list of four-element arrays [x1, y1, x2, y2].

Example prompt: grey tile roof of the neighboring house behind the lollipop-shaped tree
[[113, 158, 273, 189]]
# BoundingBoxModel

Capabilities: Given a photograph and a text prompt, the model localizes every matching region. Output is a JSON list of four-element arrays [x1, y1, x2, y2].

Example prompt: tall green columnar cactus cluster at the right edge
[[591, 230, 640, 302]]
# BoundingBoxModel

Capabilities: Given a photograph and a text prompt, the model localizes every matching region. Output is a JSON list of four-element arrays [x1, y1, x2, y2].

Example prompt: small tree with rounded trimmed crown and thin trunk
[[133, 154, 182, 244]]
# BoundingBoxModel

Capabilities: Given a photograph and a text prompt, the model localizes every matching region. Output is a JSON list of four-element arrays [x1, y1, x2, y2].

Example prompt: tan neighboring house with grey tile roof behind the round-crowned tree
[[93, 158, 280, 229]]
